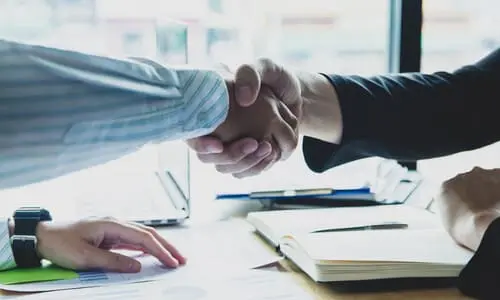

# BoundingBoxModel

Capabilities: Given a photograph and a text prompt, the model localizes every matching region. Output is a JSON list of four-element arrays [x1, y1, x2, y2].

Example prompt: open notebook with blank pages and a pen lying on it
[[248, 205, 473, 282]]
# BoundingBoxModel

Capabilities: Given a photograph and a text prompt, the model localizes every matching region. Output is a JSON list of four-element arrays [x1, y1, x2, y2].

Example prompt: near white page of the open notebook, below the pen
[[282, 229, 473, 265]]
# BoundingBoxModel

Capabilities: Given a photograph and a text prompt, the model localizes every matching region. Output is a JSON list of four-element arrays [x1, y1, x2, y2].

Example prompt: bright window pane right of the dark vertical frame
[[419, 0, 500, 180]]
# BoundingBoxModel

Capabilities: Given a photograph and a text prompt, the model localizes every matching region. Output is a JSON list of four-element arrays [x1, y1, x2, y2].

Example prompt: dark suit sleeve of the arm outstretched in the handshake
[[303, 49, 500, 172]]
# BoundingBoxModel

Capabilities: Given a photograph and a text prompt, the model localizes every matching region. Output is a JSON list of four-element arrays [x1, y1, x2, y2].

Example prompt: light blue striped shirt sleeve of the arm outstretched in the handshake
[[0, 40, 229, 188]]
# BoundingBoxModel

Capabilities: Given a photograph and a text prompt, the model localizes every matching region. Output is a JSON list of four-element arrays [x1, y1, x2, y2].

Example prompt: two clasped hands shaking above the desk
[[187, 59, 303, 178]]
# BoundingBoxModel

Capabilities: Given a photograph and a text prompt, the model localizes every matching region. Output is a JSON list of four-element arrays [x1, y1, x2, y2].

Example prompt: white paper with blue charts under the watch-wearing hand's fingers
[[0, 220, 281, 292]]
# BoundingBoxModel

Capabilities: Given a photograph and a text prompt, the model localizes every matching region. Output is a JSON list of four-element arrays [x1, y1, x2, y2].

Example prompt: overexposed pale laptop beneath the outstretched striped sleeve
[[0, 142, 190, 226]]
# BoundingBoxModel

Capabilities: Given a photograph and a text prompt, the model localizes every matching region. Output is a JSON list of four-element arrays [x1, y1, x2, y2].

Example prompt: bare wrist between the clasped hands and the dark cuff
[[297, 72, 342, 144]]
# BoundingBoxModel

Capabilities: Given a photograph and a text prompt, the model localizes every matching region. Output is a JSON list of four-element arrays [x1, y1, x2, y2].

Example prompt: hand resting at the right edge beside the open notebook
[[436, 168, 500, 251]]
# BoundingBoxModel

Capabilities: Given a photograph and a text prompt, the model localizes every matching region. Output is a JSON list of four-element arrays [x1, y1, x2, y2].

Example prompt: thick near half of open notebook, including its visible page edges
[[280, 229, 472, 282]]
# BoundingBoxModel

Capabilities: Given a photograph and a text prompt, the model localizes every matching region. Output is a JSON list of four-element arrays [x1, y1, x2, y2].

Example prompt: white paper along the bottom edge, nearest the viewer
[[15, 270, 314, 300]]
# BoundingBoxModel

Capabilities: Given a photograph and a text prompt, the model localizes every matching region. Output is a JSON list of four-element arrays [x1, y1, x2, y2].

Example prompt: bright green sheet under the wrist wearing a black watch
[[0, 262, 78, 285]]
